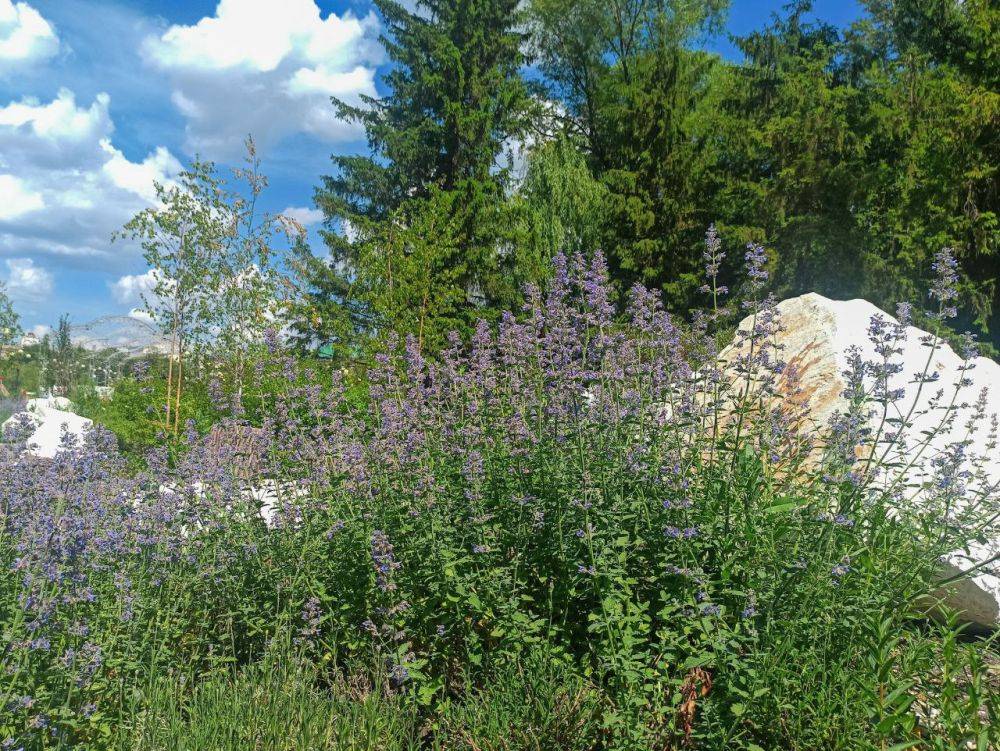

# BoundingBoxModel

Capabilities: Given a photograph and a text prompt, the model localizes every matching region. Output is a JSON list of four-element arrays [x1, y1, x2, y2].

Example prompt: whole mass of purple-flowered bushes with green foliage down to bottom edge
[[0, 244, 1000, 751]]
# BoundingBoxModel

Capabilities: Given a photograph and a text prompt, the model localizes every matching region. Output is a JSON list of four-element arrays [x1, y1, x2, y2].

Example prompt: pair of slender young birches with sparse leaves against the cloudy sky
[[122, 138, 292, 435]]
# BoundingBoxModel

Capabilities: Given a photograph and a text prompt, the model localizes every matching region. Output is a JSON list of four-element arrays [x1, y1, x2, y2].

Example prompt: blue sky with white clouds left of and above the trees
[[0, 0, 860, 330]]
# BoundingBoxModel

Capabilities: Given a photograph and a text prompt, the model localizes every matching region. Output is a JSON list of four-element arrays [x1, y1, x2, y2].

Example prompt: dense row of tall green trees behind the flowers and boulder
[[295, 0, 1000, 357]]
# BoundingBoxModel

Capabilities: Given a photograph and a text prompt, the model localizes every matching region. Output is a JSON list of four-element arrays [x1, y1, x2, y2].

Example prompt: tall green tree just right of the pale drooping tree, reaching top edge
[[530, 0, 728, 311]]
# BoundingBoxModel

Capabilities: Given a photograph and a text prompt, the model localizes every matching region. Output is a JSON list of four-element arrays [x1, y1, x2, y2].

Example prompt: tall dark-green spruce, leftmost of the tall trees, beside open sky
[[316, 0, 531, 352]]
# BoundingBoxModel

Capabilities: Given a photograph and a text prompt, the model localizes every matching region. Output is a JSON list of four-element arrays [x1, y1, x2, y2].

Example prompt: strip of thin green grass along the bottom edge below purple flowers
[[113, 651, 600, 751]]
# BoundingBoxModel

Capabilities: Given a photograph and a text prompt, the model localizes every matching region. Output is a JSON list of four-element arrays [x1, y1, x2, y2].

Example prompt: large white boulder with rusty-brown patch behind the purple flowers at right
[[741, 293, 1000, 628]]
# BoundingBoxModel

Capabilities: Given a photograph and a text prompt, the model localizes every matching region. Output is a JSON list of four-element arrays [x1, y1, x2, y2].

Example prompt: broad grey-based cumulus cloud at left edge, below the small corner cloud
[[0, 88, 181, 267]]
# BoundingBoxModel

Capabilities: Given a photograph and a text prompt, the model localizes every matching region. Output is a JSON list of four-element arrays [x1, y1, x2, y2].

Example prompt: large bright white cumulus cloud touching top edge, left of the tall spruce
[[143, 0, 382, 158]]
